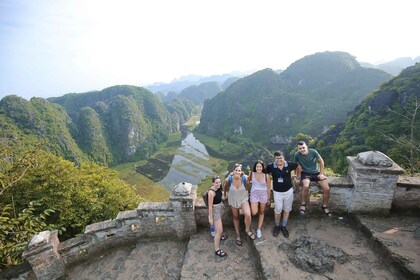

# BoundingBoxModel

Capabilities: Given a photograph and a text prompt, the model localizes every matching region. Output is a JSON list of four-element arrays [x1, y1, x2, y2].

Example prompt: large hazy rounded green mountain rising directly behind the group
[[198, 52, 391, 144]]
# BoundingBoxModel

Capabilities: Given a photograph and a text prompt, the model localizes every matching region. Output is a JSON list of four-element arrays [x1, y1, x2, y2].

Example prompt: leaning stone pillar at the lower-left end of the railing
[[22, 230, 66, 280]]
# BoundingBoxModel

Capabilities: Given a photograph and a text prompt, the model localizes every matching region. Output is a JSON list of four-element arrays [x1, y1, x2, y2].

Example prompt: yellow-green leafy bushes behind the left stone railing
[[0, 146, 141, 269]]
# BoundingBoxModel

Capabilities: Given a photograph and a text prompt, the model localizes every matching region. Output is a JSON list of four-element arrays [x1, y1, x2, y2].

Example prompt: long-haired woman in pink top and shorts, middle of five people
[[248, 160, 271, 238]]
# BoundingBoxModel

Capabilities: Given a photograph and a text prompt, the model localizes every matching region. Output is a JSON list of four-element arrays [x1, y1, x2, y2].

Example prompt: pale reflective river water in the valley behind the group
[[158, 131, 212, 191]]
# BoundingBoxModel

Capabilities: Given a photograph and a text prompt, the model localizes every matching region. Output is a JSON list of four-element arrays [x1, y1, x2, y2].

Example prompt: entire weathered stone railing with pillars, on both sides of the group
[[23, 151, 420, 279]]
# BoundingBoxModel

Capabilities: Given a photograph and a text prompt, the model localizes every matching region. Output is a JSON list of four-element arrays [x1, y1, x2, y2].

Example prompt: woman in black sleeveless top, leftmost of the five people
[[208, 176, 227, 257]]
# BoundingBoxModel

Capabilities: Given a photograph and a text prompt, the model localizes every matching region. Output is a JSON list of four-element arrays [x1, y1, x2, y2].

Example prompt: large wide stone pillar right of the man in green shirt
[[347, 151, 404, 214]]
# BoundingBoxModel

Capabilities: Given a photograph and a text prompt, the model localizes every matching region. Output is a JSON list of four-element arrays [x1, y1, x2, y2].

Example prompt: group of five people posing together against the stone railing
[[208, 141, 331, 257]]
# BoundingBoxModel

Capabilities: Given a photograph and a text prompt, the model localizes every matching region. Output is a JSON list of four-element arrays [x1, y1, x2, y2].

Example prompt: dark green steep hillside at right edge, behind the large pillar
[[317, 63, 420, 172]]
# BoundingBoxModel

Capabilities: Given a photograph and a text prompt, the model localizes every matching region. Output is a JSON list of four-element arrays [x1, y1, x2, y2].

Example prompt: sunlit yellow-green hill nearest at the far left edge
[[0, 95, 87, 163]]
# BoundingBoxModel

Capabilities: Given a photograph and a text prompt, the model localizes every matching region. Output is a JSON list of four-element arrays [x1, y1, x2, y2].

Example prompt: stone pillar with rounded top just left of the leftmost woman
[[169, 182, 197, 240]]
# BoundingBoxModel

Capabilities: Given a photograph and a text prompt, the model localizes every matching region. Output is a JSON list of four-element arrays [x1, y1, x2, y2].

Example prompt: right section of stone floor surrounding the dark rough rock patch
[[251, 213, 420, 279]]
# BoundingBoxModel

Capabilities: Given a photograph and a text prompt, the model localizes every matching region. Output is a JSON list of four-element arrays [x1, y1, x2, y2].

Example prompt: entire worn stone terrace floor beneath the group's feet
[[0, 213, 420, 280]]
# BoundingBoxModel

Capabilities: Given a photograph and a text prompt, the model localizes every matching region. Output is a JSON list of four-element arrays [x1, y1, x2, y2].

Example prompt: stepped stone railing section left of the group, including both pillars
[[23, 182, 197, 279]]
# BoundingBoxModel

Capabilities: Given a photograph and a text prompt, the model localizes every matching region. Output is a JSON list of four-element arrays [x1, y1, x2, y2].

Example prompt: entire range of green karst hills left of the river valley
[[0, 86, 194, 166]]
